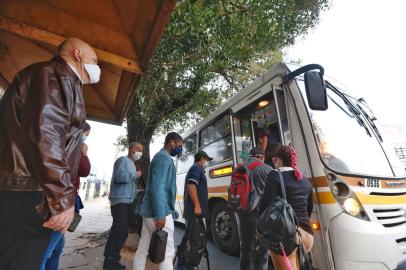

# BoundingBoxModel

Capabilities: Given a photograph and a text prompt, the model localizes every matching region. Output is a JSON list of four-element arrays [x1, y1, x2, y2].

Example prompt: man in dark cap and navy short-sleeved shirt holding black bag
[[176, 150, 213, 270]]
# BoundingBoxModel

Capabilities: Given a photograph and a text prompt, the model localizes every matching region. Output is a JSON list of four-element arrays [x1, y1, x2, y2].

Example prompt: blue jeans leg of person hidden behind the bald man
[[39, 231, 65, 270]]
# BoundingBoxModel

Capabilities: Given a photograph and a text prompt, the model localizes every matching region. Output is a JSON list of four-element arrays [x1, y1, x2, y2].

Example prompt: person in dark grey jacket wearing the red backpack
[[234, 147, 272, 270]]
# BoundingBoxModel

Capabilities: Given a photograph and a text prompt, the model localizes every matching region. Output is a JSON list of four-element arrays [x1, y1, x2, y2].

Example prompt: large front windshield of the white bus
[[297, 80, 406, 178]]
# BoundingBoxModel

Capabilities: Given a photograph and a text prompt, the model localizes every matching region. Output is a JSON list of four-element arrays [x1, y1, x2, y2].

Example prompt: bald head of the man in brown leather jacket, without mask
[[58, 38, 98, 83]]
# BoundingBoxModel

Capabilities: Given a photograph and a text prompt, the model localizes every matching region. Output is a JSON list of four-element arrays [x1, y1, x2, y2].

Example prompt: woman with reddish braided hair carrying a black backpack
[[257, 146, 313, 270]]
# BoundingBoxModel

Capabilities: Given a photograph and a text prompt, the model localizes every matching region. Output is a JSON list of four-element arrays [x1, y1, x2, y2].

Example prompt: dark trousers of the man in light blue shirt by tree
[[104, 203, 131, 263]]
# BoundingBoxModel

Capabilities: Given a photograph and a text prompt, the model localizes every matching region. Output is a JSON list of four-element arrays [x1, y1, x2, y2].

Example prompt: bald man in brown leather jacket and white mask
[[0, 38, 100, 269]]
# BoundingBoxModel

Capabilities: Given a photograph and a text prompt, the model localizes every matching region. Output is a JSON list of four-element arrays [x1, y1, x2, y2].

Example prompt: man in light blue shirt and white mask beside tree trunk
[[103, 142, 144, 270]]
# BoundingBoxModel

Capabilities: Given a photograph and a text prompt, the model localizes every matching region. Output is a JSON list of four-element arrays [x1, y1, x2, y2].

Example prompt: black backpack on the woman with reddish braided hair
[[257, 171, 298, 256]]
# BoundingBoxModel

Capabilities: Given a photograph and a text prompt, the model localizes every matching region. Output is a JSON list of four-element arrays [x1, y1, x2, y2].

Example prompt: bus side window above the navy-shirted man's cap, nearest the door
[[199, 115, 233, 164]]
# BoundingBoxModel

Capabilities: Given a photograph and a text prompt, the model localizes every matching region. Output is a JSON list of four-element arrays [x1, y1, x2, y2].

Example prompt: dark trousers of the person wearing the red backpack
[[237, 212, 268, 270]]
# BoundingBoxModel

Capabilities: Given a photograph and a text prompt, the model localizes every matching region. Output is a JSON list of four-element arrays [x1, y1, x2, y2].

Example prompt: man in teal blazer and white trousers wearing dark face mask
[[133, 132, 183, 270]]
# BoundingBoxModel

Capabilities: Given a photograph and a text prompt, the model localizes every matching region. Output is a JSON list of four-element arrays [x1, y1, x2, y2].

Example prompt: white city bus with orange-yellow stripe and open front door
[[176, 64, 406, 270]]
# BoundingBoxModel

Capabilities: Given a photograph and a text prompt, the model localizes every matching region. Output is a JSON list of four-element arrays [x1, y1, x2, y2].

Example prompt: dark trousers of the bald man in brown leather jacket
[[0, 191, 52, 270]]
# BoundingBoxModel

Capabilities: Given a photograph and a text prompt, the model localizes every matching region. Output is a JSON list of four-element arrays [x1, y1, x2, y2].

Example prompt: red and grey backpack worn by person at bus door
[[228, 161, 262, 212]]
